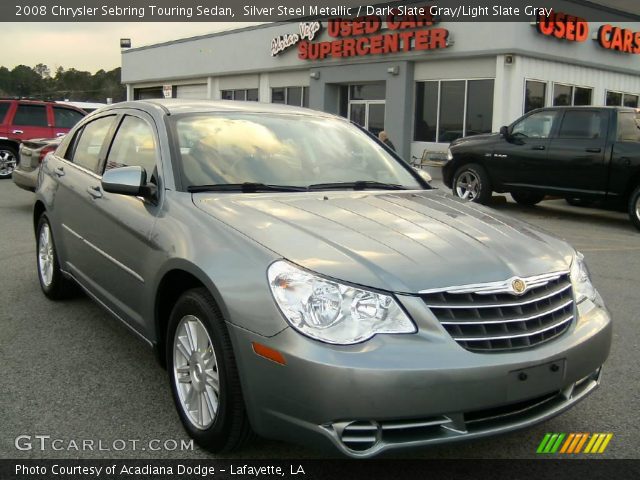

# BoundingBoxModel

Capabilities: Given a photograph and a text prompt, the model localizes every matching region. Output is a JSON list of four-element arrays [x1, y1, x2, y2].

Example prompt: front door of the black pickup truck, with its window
[[487, 110, 559, 190]]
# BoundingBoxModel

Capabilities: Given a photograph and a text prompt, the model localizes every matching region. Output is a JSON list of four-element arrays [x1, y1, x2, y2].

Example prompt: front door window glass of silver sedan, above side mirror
[[105, 116, 156, 179]]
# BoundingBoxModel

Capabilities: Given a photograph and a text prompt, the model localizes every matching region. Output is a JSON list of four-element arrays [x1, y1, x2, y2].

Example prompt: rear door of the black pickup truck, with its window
[[544, 108, 609, 195]]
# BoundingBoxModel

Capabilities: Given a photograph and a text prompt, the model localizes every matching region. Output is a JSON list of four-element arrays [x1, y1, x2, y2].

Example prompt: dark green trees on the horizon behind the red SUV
[[0, 63, 126, 102]]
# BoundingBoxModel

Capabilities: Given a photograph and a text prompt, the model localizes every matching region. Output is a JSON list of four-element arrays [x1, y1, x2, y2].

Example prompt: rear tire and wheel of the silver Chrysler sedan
[[36, 214, 76, 300]]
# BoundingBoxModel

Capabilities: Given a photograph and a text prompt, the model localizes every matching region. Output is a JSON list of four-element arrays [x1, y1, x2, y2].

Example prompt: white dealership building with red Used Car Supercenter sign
[[122, 2, 640, 168]]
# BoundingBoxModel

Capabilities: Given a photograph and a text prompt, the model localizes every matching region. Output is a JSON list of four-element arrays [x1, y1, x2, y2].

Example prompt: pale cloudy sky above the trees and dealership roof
[[0, 22, 262, 73]]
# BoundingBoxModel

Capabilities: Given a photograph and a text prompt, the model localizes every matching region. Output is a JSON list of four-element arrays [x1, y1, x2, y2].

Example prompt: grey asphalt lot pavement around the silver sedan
[[0, 180, 640, 459]]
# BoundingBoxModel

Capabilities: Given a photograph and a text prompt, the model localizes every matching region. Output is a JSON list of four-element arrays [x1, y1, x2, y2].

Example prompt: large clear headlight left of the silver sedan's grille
[[267, 261, 416, 345]]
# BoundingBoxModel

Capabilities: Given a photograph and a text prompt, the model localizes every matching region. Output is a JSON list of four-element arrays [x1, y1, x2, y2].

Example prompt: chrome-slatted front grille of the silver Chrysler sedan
[[421, 272, 574, 352]]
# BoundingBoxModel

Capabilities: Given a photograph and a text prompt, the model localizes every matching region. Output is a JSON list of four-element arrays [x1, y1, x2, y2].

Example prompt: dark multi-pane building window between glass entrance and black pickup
[[413, 79, 494, 143]]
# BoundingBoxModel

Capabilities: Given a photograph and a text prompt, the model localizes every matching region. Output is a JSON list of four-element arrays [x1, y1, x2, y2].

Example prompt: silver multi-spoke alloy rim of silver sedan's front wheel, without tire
[[173, 315, 220, 430]]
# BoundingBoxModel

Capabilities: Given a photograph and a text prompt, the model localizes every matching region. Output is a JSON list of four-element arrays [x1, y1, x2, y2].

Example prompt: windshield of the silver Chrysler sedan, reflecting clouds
[[174, 113, 424, 189]]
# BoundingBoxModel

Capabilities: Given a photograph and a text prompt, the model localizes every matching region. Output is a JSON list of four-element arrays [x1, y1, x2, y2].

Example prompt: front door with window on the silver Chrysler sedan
[[78, 111, 162, 334]]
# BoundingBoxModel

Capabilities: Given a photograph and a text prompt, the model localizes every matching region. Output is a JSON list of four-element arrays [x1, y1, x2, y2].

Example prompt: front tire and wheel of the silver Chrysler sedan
[[166, 288, 251, 453]]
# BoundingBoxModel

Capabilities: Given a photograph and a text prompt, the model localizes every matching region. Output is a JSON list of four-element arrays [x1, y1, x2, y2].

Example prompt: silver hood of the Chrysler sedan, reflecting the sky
[[193, 190, 573, 293]]
